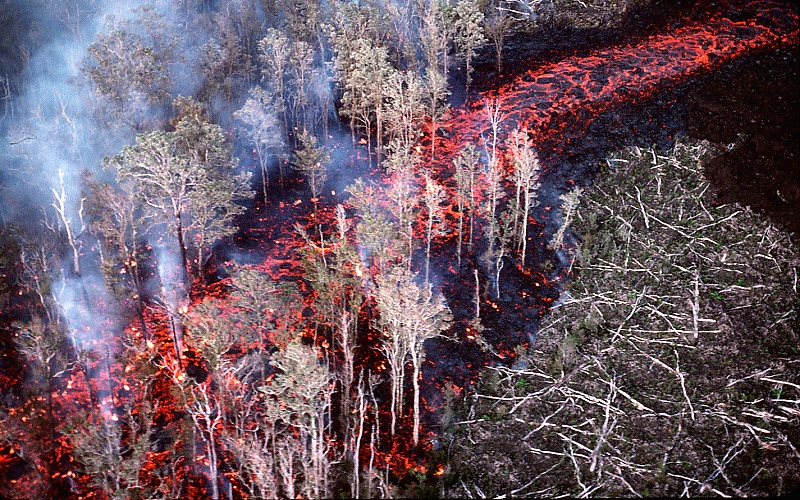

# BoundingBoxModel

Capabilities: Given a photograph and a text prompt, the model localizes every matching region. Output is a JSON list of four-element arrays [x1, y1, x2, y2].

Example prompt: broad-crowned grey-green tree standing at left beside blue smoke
[[106, 97, 253, 280]]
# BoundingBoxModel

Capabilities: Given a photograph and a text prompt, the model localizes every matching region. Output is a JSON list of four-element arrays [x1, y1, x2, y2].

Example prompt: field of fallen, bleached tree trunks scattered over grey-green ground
[[444, 143, 800, 498]]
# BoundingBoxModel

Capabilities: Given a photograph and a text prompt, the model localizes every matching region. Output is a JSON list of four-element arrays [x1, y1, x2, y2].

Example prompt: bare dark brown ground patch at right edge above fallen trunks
[[687, 49, 800, 233]]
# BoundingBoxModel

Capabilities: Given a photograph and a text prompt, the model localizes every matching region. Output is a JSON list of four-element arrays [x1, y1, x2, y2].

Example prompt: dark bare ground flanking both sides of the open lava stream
[[472, 0, 800, 234]]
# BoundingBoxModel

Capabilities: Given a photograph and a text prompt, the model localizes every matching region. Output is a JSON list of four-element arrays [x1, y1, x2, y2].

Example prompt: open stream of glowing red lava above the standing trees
[[436, 2, 798, 165]]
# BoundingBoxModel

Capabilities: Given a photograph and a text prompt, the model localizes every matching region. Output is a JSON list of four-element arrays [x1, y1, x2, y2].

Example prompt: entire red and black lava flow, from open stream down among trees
[[0, 2, 798, 498]]
